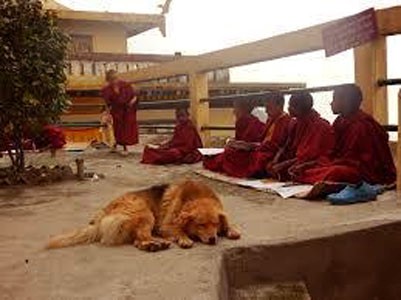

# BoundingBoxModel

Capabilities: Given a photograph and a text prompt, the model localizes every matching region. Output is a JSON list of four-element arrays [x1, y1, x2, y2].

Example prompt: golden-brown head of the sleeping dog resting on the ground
[[176, 201, 225, 245]]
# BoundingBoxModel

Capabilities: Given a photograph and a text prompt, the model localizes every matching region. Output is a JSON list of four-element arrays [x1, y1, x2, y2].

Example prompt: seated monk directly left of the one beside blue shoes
[[267, 92, 334, 181]]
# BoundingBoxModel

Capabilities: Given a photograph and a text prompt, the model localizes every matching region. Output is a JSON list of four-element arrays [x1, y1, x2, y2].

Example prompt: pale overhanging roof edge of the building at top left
[[56, 9, 165, 37]]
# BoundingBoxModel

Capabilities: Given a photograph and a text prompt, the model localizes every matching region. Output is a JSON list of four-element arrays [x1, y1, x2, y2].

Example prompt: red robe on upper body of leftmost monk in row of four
[[235, 114, 266, 143]]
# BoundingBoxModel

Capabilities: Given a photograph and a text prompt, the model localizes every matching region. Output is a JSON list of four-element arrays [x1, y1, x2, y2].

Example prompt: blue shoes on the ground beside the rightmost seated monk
[[327, 185, 377, 205]]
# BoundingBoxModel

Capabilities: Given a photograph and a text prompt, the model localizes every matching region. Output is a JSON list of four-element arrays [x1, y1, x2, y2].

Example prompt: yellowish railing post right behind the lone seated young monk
[[189, 73, 210, 147]]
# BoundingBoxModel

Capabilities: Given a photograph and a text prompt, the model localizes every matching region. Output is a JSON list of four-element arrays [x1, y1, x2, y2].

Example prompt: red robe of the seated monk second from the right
[[280, 110, 335, 180]]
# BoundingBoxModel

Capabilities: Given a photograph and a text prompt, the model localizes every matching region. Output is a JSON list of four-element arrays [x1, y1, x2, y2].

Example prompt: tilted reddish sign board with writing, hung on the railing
[[322, 8, 379, 56]]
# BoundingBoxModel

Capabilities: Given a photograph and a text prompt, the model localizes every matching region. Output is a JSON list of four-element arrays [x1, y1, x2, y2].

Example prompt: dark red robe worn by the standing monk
[[101, 81, 138, 145]]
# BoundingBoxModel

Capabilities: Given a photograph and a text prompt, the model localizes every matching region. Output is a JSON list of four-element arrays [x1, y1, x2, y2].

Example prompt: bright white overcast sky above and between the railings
[[58, 0, 401, 124]]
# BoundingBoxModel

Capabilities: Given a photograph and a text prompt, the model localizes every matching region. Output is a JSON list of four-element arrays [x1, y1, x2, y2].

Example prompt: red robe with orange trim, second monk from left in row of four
[[203, 113, 291, 178]]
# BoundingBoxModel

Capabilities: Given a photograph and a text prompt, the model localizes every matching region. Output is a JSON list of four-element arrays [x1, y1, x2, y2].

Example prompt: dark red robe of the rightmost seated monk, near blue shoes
[[297, 111, 396, 184]]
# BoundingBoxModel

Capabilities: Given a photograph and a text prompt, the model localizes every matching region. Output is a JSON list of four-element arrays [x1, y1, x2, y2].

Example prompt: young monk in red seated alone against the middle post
[[141, 108, 202, 165]]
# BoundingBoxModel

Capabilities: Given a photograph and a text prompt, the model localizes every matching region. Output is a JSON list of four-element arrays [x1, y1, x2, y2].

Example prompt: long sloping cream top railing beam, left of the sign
[[121, 22, 331, 82]]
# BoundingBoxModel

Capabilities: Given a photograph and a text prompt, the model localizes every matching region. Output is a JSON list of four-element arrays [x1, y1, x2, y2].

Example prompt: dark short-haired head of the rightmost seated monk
[[331, 84, 363, 115]]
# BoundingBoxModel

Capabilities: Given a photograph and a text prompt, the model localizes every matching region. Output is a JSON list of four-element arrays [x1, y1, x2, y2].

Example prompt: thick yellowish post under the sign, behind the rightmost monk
[[354, 36, 388, 124]]
